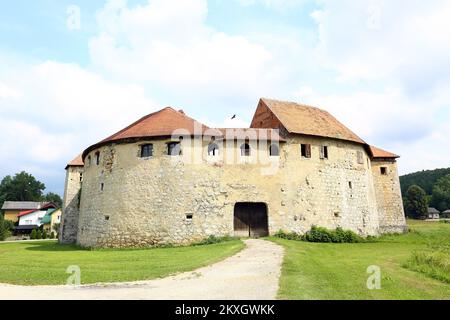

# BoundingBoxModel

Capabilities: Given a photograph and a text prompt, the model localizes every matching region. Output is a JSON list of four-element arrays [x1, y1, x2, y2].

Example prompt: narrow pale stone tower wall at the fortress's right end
[[372, 159, 407, 233]]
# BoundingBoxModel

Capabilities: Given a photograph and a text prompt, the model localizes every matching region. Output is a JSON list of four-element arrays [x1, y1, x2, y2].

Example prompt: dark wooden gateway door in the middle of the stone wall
[[234, 202, 269, 238]]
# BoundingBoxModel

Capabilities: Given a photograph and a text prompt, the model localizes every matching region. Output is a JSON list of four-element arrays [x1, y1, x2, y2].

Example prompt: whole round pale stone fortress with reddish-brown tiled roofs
[[60, 99, 406, 247]]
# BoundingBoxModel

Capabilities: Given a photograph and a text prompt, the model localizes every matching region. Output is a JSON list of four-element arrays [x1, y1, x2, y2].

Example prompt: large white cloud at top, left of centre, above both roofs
[[90, 0, 274, 98]]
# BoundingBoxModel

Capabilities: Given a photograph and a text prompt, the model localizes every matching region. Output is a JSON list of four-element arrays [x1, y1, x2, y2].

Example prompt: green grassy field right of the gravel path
[[271, 221, 450, 299]]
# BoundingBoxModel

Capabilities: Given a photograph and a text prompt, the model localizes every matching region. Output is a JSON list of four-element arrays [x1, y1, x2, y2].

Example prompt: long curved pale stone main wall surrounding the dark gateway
[[77, 135, 405, 247]]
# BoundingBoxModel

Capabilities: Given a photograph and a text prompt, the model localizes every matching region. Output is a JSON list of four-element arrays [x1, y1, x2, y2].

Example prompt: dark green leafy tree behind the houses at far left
[[0, 171, 45, 205]]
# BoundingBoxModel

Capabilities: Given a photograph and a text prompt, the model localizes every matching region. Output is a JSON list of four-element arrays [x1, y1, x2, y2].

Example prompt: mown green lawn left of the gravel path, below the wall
[[0, 240, 245, 285]]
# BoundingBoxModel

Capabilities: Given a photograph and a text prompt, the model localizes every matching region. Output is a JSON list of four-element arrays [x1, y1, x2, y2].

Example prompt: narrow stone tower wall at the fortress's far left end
[[59, 166, 84, 244]]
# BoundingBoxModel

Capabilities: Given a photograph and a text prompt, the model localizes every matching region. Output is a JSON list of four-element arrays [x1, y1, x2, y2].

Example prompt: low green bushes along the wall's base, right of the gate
[[275, 226, 365, 243]]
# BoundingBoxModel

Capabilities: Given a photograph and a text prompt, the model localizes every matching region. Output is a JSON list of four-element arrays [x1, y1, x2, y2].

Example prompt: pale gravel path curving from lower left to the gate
[[0, 239, 284, 300]]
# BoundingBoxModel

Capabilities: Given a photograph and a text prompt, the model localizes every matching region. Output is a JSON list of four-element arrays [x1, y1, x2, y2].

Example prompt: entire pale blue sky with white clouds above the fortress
[[0, 0, 450, 194]]
